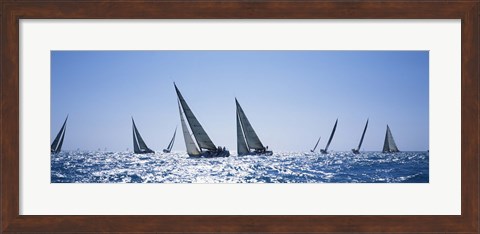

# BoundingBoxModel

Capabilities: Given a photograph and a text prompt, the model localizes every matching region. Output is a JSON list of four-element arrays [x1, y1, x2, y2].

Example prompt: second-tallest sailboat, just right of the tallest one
[[235, 98, 273, 156]]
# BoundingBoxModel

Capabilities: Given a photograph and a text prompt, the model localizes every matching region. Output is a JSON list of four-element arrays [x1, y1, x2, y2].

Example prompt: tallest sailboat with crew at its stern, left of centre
[[173, 83, 230, 158]]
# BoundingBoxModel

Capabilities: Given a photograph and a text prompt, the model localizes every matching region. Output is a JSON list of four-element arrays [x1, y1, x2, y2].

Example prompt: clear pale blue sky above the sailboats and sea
[[50, 51, 429, 151]]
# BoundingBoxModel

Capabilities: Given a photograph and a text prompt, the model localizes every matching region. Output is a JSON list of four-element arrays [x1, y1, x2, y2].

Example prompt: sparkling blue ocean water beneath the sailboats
[[51, 151, 429, 183]]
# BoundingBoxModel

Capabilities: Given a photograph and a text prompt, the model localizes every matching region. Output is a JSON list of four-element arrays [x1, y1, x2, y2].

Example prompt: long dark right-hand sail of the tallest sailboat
[[175, 85, 217, 150]]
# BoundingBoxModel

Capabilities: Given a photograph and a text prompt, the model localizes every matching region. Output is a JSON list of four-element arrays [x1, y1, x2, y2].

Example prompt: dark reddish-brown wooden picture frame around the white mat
[[0, 0, 480, 233]]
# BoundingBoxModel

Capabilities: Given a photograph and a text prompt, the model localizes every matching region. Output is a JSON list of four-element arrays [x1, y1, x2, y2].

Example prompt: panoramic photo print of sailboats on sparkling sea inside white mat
[[50, 51, 429, 183]]
